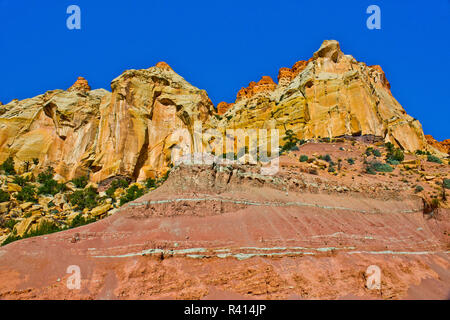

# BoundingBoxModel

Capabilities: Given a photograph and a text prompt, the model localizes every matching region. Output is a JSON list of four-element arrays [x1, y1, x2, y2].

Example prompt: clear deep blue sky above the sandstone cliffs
[[0, 0, 450, 140]]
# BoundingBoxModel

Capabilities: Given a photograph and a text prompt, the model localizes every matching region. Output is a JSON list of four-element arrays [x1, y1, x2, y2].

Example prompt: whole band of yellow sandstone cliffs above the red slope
[[0, 41, 448, 182]]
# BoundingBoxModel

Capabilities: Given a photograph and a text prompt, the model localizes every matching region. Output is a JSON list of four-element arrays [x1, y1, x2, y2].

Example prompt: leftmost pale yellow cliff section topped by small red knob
[[0, 81, 110, 178]]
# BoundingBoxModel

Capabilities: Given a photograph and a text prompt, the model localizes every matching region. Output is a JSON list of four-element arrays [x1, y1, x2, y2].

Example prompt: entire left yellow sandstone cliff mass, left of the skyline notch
[[0, 62, 214, 181]]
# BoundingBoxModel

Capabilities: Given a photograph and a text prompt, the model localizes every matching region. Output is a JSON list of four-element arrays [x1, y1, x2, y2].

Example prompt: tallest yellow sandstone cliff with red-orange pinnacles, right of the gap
[[218, 40, 436, 152]]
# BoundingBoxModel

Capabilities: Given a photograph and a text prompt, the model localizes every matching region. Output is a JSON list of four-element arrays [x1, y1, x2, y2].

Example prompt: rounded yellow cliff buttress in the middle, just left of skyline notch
[[92, 63, 214, 181]]
